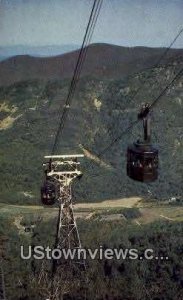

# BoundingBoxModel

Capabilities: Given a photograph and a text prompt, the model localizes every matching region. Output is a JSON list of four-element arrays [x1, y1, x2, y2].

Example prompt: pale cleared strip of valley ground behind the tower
[[0, 197, 183, 228]]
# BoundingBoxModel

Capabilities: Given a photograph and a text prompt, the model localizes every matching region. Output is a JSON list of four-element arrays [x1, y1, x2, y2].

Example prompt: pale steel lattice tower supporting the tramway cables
[[39, 154, 85, 300]]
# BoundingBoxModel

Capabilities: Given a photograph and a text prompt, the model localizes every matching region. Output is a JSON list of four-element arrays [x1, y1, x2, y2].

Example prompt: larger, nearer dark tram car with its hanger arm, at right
[[127, 104, 158, 183]]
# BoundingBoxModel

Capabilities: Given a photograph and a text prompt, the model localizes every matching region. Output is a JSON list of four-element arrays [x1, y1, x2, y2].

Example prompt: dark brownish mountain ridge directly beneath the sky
[[0, 44, 183, 86]]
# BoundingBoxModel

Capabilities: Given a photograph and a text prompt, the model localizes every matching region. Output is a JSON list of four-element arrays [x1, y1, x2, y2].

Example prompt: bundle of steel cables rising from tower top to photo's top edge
[[52, 0, 103, 154]]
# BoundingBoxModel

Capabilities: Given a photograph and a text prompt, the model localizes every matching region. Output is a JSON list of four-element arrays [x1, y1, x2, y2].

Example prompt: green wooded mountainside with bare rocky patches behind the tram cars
[[0, 46, 183, 204]]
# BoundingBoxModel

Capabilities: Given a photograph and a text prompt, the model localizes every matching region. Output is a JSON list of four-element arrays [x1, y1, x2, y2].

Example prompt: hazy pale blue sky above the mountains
[[0, 0, 183, 48]]
